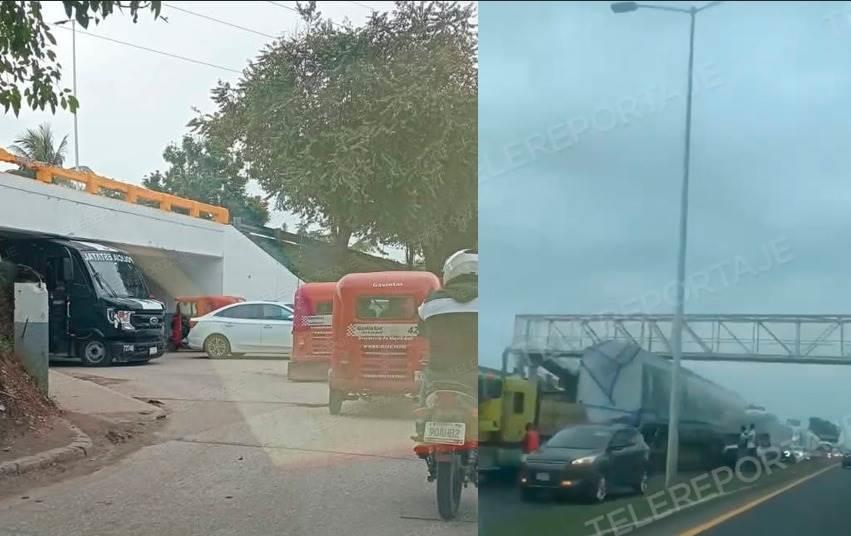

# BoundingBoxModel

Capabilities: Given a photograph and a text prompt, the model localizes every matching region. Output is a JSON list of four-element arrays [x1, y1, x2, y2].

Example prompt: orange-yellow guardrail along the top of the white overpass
[[0, 148, 230, 224]]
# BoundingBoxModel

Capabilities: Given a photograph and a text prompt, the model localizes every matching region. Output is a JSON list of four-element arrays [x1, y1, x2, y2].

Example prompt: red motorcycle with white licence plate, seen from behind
[[414, 381, 478, 521]]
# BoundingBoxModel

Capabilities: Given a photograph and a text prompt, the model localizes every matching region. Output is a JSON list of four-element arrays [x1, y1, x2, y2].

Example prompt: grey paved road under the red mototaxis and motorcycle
[[0, 353, 477, 536]]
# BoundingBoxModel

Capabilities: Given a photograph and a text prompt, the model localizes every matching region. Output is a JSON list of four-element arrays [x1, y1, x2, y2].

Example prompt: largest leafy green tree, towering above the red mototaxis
[[191, 2, 477, 271]]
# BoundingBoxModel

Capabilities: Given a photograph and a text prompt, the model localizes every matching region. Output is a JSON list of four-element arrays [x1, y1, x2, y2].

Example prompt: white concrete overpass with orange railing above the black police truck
[[0, 149, 299, 303]]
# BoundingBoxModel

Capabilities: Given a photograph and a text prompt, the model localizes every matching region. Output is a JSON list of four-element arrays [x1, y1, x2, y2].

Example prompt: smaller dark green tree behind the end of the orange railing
[[142, 136, 269, 225]]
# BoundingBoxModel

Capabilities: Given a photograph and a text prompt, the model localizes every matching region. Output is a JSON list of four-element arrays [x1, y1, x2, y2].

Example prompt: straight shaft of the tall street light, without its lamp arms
[[665, 6, 697, 487]]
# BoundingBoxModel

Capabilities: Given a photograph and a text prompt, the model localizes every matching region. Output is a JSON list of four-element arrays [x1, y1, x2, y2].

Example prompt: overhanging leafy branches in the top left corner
[[0, 0, 162, 115]]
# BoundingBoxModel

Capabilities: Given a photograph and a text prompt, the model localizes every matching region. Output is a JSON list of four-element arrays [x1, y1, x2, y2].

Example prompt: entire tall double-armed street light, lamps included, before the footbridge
[[611, 2, 721, 487]]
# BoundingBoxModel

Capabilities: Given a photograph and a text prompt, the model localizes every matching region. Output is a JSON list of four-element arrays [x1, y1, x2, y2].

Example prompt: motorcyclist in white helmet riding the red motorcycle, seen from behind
[[417, 249, 479, 436]]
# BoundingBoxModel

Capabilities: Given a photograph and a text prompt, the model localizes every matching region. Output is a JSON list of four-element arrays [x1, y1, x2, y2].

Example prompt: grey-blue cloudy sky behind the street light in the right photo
[[479, 2, 851, 426]]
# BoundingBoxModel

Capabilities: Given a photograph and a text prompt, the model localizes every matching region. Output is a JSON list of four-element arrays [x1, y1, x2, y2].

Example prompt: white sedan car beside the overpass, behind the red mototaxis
[[186, 301, 293, 359]]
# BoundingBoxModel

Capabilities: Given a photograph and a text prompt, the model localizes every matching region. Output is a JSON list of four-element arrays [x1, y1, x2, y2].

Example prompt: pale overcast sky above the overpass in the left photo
[[0, 1, 382, 232]]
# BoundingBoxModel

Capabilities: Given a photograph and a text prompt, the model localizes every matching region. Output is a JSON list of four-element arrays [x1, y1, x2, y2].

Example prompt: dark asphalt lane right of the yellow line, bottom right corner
[[704, 467, 851, 536]]
